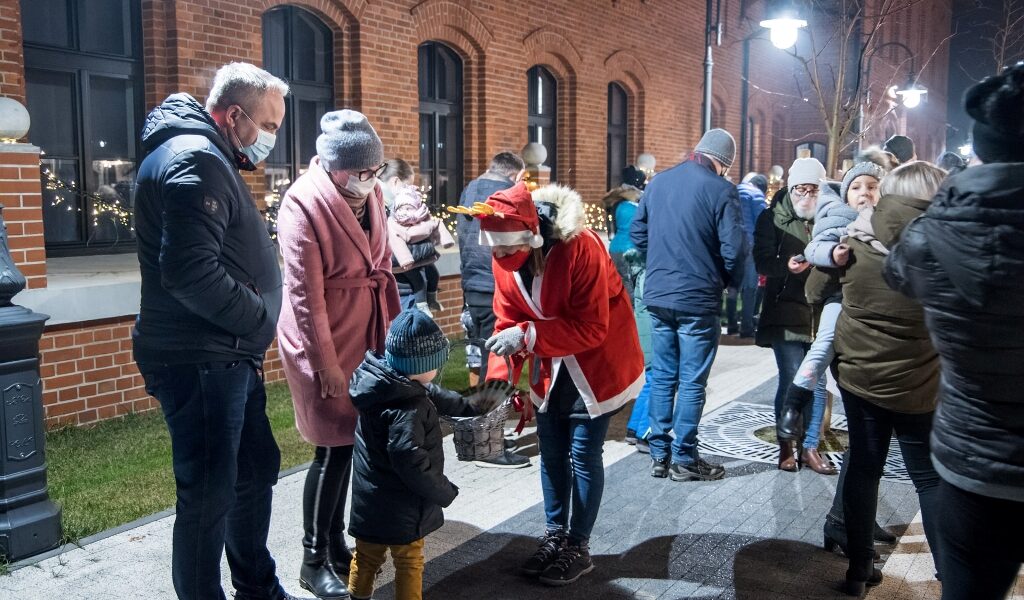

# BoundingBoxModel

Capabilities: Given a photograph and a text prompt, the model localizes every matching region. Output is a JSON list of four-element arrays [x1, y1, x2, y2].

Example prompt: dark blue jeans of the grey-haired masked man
[[138, 360, 285, 600]]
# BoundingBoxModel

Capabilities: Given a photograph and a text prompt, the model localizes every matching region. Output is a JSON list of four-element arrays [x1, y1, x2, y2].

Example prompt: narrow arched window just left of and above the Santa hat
[[419, 42, 462, 207]]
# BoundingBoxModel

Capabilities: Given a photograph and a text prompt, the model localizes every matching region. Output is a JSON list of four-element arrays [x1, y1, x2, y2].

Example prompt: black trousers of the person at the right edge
[[937, 480, 1024, 600]]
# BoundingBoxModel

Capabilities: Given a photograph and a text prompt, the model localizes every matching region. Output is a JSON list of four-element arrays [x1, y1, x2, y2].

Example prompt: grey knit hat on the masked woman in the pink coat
[[316, 109, 384, 171]]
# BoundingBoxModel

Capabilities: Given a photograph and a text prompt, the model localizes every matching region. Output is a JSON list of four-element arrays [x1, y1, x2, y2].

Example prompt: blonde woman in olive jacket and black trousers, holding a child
[[834, 162, 945, 596]]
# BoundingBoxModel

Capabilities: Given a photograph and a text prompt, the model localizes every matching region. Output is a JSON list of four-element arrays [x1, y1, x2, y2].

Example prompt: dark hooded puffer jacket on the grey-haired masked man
[[132, 94, 282, 363]]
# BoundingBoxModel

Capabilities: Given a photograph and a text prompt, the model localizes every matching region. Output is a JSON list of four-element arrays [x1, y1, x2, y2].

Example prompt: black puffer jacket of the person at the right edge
[[885, 163, 1024, 502]]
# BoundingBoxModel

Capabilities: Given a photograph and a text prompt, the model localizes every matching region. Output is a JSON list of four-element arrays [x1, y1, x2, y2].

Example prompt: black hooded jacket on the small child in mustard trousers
[[348, 352, 473, 545]]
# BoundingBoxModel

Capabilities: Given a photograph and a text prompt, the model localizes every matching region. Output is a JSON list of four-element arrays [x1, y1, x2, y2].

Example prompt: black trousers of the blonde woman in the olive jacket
[[840, 386, 939, 564]]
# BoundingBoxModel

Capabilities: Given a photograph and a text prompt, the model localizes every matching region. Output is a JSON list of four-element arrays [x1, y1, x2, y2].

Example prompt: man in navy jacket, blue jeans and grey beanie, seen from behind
[[630, 129, 748, 481]]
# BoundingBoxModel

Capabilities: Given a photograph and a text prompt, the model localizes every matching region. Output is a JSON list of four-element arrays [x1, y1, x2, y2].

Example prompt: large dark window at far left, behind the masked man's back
[[20, 0, 144, 251]]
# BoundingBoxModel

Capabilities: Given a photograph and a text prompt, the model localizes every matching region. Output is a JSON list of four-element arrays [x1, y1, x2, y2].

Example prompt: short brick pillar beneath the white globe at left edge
[[0, 143, 46, 289]]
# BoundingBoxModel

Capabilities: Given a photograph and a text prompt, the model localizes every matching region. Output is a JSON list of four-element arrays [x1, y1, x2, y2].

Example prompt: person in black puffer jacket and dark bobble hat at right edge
[[886, 63, 1024, 600]]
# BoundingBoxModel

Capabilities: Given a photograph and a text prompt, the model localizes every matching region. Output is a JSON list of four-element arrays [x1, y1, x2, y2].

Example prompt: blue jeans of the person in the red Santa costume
[[537, 410, 611, 544]]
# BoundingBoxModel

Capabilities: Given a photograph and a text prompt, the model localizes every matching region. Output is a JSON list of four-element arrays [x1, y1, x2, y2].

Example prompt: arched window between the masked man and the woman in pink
[[263, 6, 334, 195]]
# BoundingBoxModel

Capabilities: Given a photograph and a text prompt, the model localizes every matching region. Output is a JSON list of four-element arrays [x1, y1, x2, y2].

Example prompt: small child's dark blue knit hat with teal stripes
[[384, 308, 449, 375]]
